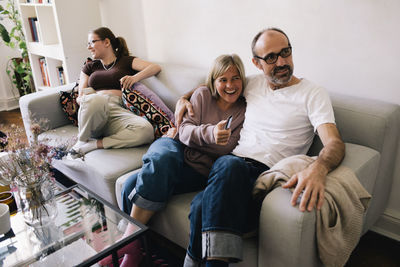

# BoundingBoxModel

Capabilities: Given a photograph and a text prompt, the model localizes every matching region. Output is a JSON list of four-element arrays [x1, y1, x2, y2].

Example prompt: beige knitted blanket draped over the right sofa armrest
[[253, 155, 371, 266]]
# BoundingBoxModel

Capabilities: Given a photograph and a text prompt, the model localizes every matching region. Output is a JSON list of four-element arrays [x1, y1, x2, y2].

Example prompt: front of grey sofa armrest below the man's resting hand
[[258, 187, 319, 267]]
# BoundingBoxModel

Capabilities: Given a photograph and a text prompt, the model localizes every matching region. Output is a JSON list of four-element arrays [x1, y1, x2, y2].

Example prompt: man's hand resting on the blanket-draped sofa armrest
[[282, 162, 328, 212]]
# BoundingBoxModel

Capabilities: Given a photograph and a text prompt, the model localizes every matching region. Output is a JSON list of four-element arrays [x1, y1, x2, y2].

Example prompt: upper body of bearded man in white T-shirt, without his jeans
[[233, 28, 345, 214]]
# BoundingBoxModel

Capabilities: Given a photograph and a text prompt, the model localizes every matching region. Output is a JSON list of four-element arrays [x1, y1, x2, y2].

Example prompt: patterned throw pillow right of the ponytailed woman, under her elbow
[[122, 83, 175, 138]]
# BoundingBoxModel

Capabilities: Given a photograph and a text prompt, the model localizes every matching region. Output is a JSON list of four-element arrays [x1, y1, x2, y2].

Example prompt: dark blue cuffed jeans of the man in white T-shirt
[[185, 155, 268, 266]]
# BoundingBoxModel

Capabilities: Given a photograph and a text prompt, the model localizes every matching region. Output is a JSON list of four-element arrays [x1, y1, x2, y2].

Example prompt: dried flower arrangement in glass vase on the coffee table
[[0, 120, 70, 226]]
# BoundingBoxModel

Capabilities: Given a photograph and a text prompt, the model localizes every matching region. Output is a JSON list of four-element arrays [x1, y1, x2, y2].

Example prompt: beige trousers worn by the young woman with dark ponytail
[[78, 91, 154, 151]]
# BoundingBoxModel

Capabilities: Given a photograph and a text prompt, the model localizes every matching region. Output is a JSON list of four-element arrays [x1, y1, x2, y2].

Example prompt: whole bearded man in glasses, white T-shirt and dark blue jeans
[[176, 28, 345, 266]]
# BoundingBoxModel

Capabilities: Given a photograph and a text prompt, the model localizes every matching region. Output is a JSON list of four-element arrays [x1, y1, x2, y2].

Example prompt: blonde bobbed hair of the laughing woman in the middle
[[206, 54, 246, 98]]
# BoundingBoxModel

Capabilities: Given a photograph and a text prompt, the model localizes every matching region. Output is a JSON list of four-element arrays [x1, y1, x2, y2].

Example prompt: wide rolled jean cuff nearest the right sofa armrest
[[202, 231, 243, 262]]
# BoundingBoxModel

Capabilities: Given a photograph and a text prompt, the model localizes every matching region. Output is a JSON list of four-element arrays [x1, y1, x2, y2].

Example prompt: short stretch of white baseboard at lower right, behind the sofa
[[371, 209, 400, 241]]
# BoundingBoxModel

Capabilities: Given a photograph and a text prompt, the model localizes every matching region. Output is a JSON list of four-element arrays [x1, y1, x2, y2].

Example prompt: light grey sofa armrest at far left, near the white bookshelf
[[19, 83, 75, 141]]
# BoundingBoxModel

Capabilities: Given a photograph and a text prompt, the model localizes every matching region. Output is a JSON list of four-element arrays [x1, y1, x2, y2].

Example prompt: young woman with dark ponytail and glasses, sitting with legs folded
[[70, 27, 161, 157]]
